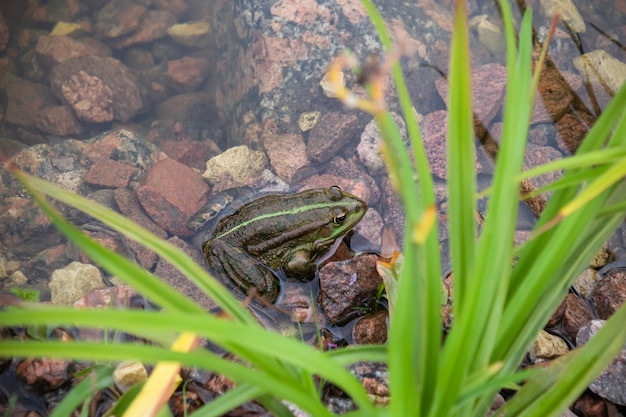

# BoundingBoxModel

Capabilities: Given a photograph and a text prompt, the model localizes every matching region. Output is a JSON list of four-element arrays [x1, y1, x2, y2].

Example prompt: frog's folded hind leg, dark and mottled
[[202, 239, 279, 303]]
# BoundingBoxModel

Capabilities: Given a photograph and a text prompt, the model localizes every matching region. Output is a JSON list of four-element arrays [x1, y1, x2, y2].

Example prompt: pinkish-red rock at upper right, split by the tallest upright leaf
[[435, 64, 506, 136]]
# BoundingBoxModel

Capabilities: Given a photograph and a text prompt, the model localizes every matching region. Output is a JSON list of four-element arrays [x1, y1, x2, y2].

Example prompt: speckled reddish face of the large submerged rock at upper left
[[61, 71, 113, 123]]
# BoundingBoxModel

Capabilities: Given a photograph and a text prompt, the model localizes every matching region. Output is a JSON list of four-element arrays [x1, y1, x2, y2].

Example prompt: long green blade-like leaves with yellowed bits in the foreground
[[0, 0, 626, 417]]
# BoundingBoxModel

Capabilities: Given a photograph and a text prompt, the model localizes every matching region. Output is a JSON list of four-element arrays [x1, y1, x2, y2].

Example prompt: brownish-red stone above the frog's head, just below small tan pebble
[[306, 112, 359, 162]]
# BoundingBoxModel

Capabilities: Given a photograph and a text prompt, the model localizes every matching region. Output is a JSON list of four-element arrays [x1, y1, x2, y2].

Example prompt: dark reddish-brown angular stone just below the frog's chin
[[319, 255, 383, 323]]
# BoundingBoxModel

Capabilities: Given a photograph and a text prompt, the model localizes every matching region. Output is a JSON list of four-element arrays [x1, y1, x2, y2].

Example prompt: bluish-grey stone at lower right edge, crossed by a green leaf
[[576, 320, 626, 405]]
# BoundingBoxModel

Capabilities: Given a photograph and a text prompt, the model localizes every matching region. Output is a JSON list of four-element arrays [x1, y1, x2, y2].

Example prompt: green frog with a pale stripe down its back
[[202, 186, 367, 303]]
